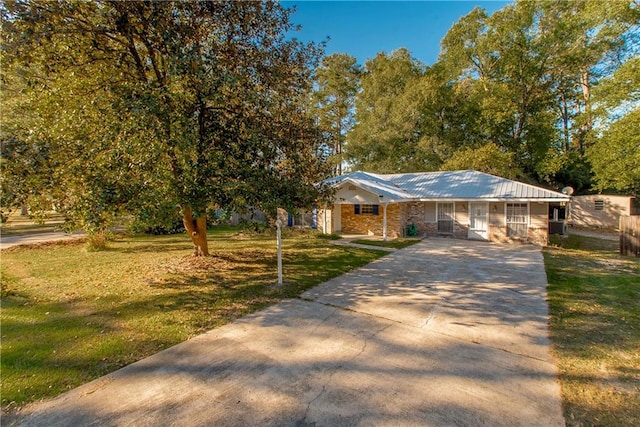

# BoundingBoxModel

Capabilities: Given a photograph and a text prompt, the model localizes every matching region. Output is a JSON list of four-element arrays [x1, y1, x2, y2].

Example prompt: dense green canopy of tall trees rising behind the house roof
[[338, 0, 640, 196]]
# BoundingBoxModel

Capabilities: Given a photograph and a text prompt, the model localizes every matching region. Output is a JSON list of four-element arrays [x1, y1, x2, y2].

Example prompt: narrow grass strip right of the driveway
[[544, 235, 640, 426]]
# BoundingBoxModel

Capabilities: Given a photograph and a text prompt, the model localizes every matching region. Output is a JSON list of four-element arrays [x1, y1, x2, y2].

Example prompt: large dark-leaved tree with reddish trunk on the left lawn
[[2, 0, 327, 255]]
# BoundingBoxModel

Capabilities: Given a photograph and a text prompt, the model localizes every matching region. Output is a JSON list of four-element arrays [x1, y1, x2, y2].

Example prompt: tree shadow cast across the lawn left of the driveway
[[1, 236, 378, 410]]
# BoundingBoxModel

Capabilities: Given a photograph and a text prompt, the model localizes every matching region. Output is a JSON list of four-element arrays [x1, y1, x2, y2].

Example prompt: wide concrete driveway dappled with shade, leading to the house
[[3, 239, 564, 426]]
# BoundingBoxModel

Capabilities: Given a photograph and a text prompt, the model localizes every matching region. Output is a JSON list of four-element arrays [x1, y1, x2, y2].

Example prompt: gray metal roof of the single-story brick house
[[327, 170, 569, 201]]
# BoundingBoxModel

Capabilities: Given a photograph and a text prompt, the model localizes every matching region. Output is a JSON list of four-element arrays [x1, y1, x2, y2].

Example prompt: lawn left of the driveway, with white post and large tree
[[0, 228, 384, 412]]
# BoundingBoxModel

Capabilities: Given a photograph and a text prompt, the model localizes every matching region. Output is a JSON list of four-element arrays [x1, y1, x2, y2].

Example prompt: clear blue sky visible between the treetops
[[281, 1, 511, 65]]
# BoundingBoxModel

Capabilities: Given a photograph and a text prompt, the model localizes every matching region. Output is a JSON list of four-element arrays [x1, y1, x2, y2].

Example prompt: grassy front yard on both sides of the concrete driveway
[[0, 228, 640, 426]]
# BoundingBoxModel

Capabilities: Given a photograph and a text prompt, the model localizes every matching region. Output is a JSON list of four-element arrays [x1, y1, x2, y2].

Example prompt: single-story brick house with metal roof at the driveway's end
[[318, 170, 570, 245]]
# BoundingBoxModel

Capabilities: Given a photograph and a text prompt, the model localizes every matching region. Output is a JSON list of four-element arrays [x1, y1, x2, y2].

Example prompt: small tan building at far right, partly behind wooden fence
[[569, 194, 640, 229]]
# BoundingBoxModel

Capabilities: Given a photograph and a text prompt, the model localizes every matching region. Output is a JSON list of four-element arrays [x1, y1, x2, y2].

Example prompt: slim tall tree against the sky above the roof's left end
[[312, 53, 361, 176]]
